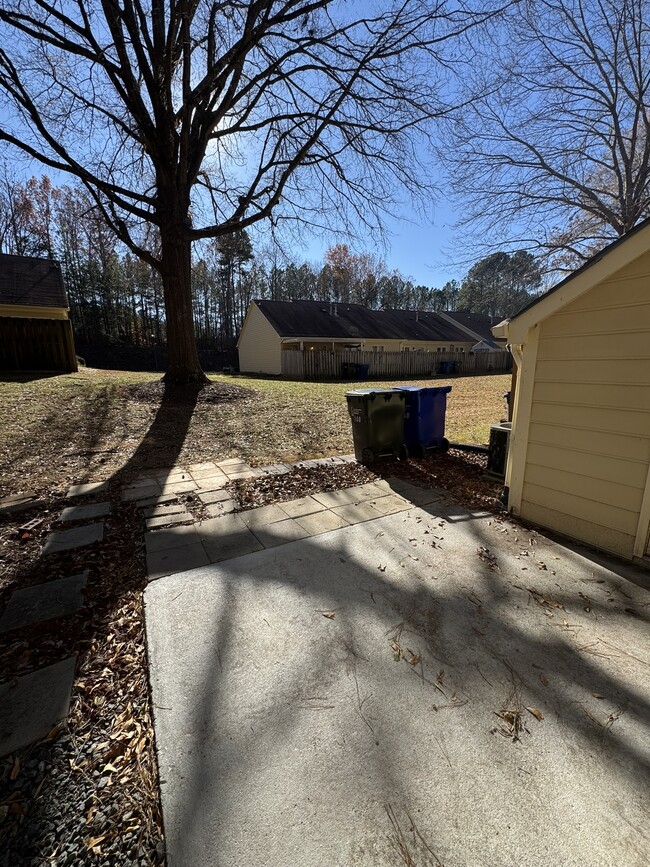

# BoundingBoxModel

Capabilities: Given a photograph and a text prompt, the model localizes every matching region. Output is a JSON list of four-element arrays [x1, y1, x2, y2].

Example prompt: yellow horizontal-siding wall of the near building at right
[[517, 253, 650, 557]]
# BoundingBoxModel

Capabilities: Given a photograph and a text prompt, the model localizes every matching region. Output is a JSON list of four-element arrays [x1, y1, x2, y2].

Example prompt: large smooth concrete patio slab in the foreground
[[145, 504, 650, 867]]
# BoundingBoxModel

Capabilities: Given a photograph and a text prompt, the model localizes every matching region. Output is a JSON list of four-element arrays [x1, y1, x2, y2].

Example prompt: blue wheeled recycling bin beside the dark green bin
[[396, 385, 451, 457]]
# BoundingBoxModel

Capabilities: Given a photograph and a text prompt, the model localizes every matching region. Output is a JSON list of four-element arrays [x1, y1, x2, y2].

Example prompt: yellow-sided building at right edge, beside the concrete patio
[[494, 220, 650, 558]]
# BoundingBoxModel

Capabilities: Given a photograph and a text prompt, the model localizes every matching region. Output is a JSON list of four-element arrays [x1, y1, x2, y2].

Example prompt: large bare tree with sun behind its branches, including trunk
[[0, 0, 496, 382]]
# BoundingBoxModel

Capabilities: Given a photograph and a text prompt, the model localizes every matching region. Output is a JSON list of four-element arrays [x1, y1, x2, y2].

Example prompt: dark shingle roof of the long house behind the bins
[[255, 301, 471, 342]]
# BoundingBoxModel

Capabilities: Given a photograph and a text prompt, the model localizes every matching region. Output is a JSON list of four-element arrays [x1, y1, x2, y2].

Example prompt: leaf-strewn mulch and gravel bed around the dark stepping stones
[[0, 492, 164, 867]]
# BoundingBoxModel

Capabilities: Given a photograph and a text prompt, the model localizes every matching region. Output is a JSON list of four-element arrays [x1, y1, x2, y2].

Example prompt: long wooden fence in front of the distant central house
[[282, 349, 512, 381]]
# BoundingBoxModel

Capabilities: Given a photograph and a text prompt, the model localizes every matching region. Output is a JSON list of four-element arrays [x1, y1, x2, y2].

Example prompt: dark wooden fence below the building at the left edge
[[0, 316, 77, 371]]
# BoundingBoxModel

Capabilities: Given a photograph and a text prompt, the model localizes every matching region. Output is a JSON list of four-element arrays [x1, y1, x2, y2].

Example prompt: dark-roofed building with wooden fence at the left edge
[[0, 254, 77, 371]]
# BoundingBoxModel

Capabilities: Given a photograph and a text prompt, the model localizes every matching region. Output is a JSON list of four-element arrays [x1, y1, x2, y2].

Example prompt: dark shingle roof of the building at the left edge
[[0, 253, 68, 307]]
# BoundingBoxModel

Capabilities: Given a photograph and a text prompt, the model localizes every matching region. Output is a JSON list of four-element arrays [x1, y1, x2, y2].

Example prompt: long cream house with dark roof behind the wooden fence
[[237, 301, 498, 374]]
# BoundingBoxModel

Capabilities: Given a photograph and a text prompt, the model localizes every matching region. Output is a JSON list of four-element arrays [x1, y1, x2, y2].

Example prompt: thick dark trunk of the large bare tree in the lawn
[[160, 227, 208, 385]]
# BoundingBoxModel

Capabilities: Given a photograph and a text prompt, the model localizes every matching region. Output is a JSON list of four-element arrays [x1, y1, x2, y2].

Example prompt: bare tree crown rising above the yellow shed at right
[[440, 0, 650, 267]]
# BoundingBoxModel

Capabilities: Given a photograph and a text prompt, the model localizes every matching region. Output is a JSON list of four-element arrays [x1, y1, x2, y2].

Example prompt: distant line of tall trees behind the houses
[[0, 174, 541, 352]]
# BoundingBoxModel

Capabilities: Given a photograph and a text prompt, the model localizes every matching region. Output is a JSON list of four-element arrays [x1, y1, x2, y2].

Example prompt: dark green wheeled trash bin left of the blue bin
[[345, 388, 406, 464]]
